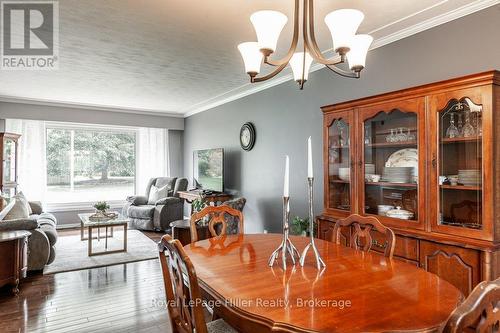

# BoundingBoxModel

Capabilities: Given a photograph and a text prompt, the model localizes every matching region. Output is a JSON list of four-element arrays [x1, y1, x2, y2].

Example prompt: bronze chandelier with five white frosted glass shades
[[238, 0, 373, 89]]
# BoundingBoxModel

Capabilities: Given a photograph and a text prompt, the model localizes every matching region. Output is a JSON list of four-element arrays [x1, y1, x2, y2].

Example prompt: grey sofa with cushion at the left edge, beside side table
[[0, 201, 57, 271]]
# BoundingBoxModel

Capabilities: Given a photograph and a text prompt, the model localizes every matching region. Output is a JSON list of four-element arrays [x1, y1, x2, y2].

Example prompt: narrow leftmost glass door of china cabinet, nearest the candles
[[325, 112, 354, 213]]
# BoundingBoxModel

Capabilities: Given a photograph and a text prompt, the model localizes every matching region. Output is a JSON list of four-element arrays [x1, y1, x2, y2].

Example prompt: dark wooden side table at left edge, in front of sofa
[[0, 231, 31, 294]]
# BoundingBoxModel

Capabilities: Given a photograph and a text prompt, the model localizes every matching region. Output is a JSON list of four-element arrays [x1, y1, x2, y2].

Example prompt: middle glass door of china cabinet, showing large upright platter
[[359, 99, 425, 228]]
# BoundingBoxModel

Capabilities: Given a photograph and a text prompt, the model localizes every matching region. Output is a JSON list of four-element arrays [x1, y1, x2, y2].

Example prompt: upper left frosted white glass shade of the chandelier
[[250, 10, 288, 53]]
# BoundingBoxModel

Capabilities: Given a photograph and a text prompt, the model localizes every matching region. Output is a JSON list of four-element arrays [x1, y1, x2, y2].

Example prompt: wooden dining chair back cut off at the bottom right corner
[[443, 279, 500, 333]]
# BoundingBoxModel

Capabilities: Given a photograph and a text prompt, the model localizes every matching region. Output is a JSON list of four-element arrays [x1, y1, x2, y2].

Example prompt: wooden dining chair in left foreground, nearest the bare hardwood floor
[[158, 235, 237, 333]]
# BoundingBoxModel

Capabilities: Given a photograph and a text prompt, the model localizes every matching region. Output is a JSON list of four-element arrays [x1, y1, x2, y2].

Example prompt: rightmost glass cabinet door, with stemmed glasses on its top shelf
[[436, 97, 483, 230]]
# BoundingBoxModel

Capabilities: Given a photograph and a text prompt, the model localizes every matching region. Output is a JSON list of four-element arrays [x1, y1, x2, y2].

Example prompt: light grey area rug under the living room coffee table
[[43, 230, 158, 274]]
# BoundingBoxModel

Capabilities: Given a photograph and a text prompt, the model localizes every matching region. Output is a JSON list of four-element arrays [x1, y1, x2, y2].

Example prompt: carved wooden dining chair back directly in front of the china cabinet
[[330, 214, 396, 258]]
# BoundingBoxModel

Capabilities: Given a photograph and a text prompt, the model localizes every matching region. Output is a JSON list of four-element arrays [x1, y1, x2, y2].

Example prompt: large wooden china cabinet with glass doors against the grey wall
[[318, 71, 500, 295]]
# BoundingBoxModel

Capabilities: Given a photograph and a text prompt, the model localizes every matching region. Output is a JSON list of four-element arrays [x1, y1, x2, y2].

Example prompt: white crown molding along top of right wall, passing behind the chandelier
[[184, 0, 500, 117]]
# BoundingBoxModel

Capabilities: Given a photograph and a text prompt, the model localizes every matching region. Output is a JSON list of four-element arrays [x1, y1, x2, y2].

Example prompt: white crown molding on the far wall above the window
[[0, 95, 184, 118]]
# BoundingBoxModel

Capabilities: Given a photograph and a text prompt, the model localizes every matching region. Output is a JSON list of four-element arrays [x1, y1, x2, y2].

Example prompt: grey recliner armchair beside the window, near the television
[[122, 177, 188, 231]]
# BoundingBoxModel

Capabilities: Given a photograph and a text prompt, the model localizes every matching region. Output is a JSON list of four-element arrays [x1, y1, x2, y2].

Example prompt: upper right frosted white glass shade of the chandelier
[[325, 9, 365, 52]]
